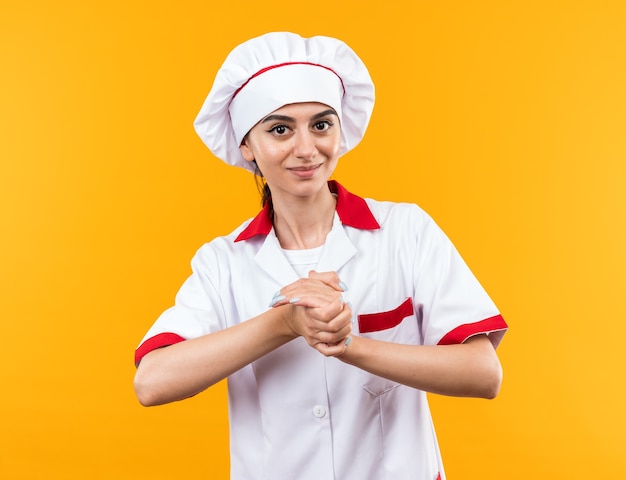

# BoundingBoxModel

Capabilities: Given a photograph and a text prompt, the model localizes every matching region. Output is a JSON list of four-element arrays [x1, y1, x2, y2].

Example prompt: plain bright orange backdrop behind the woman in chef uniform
[[0, 0, 626, 480]]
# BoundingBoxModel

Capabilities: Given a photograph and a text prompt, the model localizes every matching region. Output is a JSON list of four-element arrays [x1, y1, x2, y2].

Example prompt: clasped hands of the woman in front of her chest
[[270, 271, 353, 356]]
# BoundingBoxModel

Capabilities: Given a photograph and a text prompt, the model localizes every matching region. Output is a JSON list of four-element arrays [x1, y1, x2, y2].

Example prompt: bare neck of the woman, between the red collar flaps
[[272, 188, 337, 250]]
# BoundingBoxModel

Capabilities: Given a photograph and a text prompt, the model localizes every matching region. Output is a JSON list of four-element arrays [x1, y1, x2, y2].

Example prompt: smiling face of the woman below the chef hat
[[240, 103, 341, 201]]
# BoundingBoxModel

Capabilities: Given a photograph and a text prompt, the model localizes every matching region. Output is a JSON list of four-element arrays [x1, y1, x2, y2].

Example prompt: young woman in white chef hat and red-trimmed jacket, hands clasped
[[135, 33, 507, 480]]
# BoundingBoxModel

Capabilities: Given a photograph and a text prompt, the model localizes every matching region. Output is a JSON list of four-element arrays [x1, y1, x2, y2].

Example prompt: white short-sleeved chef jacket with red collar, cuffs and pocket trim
[[136, 181, 507, 480]]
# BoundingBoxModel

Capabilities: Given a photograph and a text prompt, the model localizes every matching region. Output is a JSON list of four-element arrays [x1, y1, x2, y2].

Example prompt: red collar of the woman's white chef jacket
[[235, 180, 380, 242]]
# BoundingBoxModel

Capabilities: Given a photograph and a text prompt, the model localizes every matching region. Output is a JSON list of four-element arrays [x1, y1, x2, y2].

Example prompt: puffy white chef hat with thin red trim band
[[194, 32, 374, 171]]
